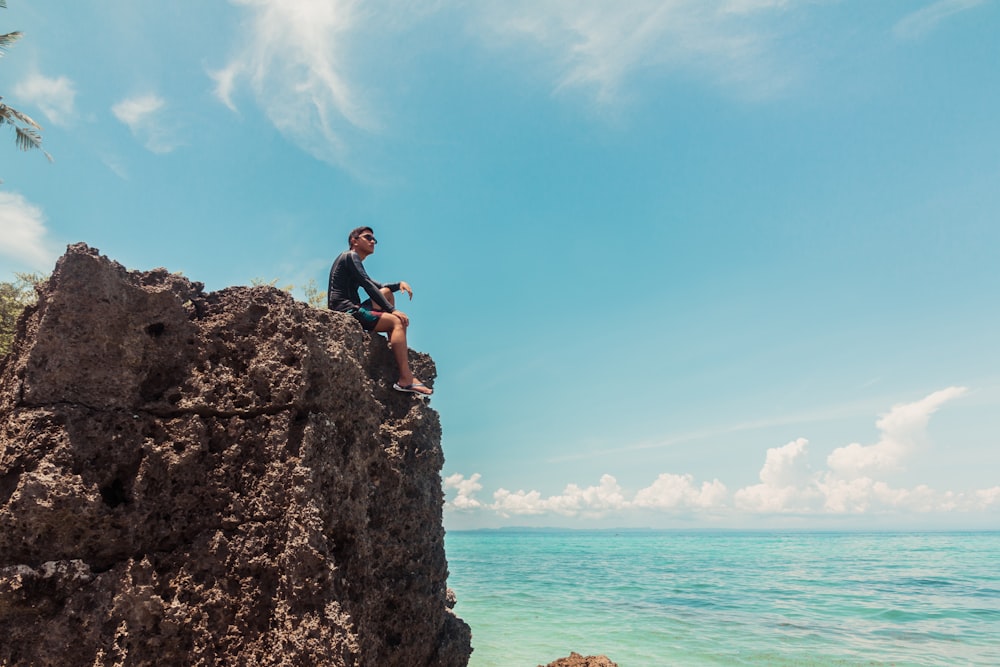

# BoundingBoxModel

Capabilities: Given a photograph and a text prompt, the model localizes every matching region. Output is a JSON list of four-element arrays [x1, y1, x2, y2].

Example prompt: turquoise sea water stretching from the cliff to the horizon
[[446, 531, 1000, 667]]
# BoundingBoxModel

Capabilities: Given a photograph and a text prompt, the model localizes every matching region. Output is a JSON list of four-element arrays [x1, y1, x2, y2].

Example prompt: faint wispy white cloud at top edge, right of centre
[[478, 0, 790, 105]]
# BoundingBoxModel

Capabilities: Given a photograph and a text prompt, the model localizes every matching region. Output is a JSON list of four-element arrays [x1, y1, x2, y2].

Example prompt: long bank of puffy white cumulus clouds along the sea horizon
[[444, 387, 1000, 519]]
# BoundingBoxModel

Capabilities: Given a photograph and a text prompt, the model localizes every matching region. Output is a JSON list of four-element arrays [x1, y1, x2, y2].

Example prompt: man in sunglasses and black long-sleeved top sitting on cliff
[[326, 227, 434, 396]]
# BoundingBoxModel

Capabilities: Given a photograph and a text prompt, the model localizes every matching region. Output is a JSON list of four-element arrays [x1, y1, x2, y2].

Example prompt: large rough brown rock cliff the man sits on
[[0, 244, 471, 667]]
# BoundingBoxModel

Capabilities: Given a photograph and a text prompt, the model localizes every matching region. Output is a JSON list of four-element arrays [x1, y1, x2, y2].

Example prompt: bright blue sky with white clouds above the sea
[[0, 0, 1000, 530]]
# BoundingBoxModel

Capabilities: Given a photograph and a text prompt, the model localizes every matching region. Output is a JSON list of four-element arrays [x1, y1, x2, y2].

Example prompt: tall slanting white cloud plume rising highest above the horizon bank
[[826, 387, 966, 478]]
